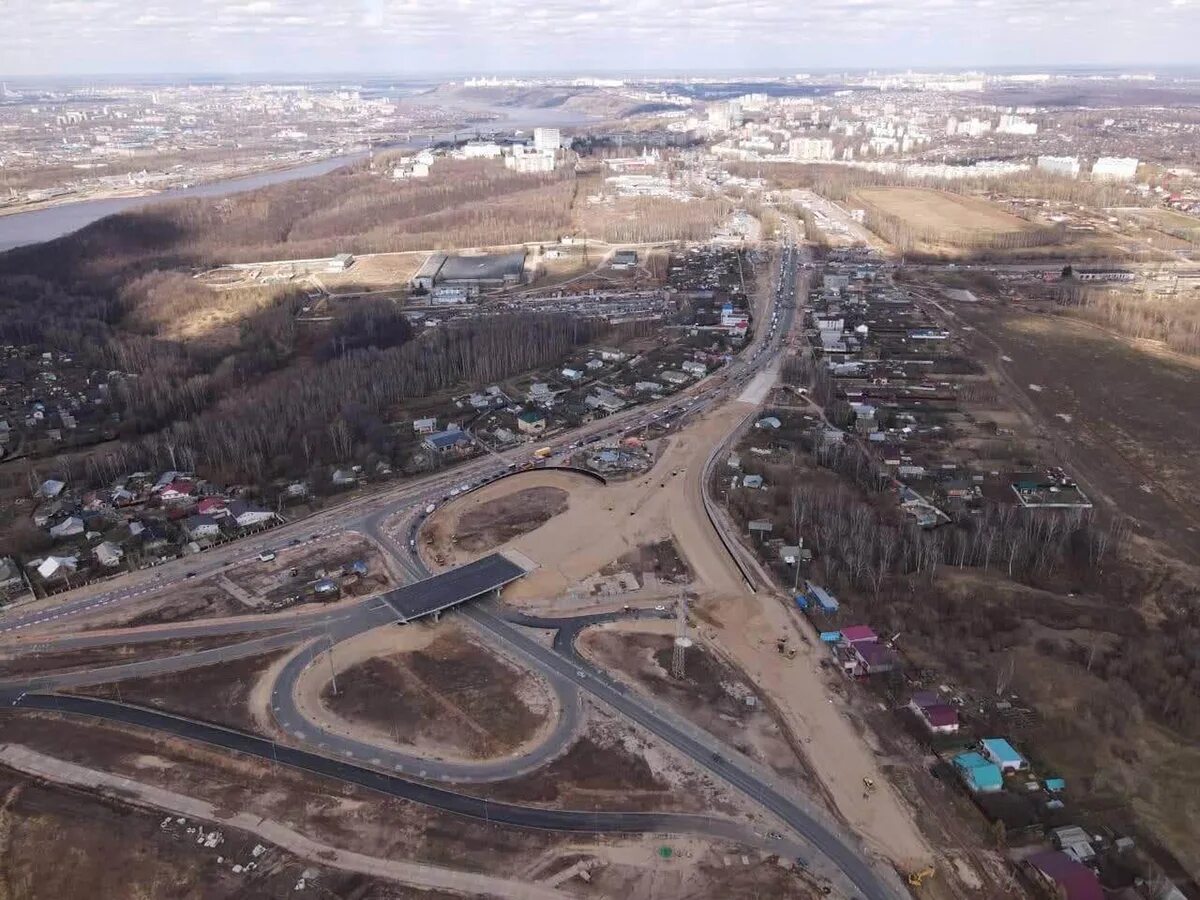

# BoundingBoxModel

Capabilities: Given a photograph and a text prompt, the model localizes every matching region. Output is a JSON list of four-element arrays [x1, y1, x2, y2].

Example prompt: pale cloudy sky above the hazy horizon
[[0, 0, 1200, 77]]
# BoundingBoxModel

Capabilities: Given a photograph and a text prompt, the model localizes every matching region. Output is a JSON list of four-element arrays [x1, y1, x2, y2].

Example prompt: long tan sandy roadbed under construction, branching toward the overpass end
[[422, 402, 932, 869]]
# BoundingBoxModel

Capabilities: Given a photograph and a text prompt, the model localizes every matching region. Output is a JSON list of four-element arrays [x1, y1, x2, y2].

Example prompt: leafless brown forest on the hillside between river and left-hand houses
[[0, 163, 657, 496]]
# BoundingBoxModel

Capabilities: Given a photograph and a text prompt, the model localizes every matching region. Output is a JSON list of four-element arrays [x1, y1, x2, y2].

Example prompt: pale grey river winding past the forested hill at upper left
[[0, 103, 589, 253]]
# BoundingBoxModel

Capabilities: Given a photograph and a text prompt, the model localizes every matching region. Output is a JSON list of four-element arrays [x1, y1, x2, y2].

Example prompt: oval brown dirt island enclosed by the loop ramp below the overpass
[[307, 622, 556, 760]]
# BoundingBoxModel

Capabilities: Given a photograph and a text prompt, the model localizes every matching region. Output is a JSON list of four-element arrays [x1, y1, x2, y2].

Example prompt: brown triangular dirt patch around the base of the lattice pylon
[[578, 622, 814, 787]]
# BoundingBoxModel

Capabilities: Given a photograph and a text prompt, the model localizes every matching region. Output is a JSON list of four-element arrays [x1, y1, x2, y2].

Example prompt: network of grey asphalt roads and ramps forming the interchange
[[0, 245, 900, 900]]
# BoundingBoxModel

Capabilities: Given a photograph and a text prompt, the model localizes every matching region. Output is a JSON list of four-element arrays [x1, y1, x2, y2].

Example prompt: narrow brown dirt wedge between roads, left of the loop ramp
[[74, 650, 287, 731]]
